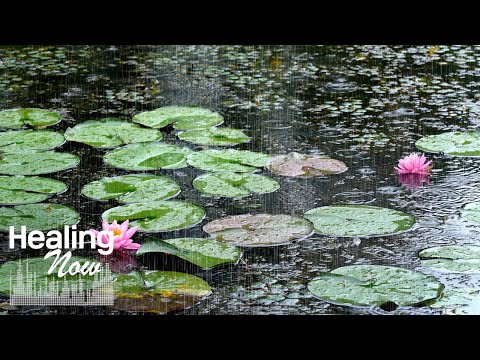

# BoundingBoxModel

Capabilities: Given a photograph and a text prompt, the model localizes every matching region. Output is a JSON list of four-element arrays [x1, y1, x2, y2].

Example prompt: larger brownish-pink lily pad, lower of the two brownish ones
[[203, 214, 313, 247]]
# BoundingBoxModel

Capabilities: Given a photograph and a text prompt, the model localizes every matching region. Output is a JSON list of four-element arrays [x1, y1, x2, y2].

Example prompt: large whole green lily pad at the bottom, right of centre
[[308, 265, 444, 306]]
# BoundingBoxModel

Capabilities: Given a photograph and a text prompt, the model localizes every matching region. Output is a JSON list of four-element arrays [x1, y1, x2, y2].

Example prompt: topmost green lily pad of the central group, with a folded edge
[[132, 106, 223, 130]]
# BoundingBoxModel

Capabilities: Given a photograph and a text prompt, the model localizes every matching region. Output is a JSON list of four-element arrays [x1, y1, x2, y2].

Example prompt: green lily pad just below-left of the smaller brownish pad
[[193, 172, 280, 197]]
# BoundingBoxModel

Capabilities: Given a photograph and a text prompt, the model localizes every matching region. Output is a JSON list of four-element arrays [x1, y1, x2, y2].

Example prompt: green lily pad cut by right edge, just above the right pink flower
[[415, 131, 480, 156]]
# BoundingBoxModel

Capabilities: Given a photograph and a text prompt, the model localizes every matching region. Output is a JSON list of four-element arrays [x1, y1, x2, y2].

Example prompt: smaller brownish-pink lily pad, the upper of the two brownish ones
[[266, 152, 348, 177]]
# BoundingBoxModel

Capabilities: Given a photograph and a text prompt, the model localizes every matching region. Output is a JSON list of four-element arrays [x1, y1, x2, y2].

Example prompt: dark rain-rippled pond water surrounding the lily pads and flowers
[[0, 46, 480, 314]]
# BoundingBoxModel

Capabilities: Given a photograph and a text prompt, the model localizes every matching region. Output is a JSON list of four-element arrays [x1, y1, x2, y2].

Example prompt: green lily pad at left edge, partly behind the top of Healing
[[0, 204, 80, 233]]
